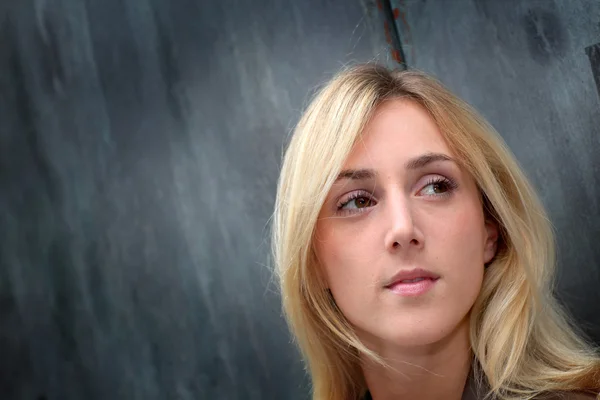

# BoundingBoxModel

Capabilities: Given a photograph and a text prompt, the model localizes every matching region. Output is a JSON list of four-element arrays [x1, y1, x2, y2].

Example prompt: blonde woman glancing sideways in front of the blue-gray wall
[[273, 65, 600, 400]]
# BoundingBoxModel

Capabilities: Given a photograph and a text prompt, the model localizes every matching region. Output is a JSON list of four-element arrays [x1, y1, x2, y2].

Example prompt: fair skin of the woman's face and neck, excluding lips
[[315, 100, 498, 400]]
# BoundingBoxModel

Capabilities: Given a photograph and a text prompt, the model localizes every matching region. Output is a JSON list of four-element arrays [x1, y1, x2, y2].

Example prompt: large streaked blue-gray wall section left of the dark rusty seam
[[0, 0, 389, 400]]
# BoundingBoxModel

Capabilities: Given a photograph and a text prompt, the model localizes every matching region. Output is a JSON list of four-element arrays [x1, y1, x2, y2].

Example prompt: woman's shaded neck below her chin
[[362, 318, 472, 400]]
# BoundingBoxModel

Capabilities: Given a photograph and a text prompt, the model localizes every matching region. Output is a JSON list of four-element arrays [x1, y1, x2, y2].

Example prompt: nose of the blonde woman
[[384, 195, 423, 251]]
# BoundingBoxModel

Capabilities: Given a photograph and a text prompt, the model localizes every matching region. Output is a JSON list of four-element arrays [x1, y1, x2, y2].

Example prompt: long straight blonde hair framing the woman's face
[[272, 64, 600, 400]]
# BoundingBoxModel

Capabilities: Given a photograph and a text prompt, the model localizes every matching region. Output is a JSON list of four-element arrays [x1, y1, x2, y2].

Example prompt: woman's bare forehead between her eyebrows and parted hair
[[344, 99, 451, 168]]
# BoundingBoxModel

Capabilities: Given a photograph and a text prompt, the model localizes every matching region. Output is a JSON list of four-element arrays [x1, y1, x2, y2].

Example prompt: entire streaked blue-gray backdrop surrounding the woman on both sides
[[0, 0, 600, 400]]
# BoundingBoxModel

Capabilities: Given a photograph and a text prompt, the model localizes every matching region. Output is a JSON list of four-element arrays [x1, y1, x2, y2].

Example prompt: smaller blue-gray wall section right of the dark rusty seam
[[392, 0, 600, 343]]
